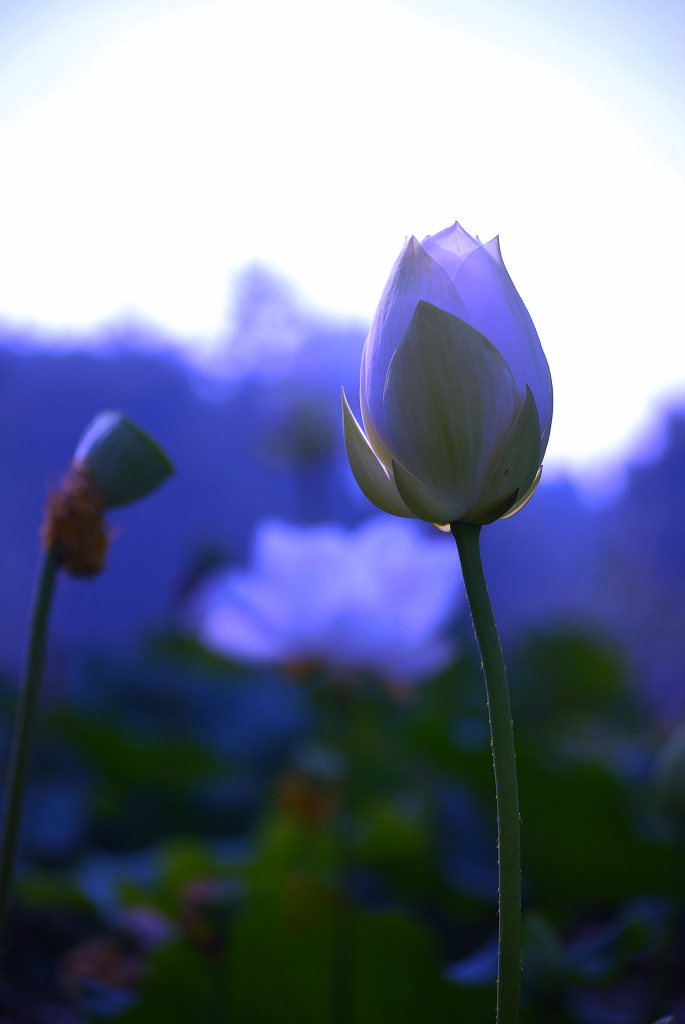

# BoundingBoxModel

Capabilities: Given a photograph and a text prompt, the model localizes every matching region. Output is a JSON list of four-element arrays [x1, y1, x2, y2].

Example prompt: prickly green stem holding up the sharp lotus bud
[[452, 522, 521, 1024]]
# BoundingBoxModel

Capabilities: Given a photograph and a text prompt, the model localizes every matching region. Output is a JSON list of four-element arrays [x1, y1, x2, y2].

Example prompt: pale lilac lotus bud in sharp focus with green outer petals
[[343, 223, 552, 523]]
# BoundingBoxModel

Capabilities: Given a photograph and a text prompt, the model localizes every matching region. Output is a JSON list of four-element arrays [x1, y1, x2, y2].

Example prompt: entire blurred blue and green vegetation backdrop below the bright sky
[[0, 276, 685, 1024]]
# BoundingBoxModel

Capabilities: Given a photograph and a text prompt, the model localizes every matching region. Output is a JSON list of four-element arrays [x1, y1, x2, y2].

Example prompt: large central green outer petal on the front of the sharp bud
[[384, 302, 520, 513]]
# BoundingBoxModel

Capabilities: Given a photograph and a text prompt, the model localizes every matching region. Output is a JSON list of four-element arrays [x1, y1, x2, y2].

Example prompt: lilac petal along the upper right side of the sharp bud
[[455, 239, 552, 454]]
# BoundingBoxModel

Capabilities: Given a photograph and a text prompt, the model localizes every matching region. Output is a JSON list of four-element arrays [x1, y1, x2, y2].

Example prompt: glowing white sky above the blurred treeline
[[0, 0, 685, 491]]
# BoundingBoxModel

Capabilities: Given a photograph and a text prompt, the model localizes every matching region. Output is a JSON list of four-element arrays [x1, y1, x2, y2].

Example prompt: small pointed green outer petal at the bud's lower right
[[474, 385, 540, 518]]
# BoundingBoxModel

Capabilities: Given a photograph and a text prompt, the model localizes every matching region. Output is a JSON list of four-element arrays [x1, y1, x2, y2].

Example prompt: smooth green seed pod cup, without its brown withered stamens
[[73, 410, 173, 508]]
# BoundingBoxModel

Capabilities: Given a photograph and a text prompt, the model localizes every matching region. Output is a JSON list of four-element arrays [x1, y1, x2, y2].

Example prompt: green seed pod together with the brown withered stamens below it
[[41, 412, 173, 577]]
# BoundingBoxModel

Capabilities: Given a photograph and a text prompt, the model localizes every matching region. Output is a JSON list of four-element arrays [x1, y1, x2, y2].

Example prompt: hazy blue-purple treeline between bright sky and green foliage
[[5, 270, 685, 716]]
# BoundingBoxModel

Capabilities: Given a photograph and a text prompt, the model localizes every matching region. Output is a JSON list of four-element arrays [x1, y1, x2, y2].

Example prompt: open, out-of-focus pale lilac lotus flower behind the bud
[[189, 519, 461, 680]]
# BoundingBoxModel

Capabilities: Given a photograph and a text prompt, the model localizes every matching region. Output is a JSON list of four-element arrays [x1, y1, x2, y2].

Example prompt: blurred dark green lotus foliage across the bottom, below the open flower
[[9, 634, 682, 1024]]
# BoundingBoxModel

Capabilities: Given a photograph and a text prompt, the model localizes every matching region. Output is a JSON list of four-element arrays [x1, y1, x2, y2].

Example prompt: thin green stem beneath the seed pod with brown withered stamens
[[0, 548, 59, 955]]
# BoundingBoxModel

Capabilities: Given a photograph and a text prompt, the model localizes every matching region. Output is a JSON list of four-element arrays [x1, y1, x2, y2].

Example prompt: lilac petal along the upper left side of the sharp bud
[[360, 238, 465, 469]]
